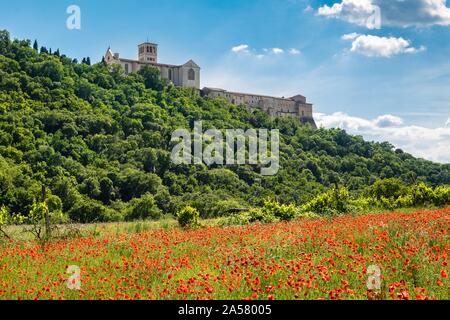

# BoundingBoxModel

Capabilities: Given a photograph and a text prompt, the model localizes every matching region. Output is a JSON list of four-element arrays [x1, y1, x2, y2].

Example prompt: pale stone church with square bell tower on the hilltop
[[104, 42, 200, 89]]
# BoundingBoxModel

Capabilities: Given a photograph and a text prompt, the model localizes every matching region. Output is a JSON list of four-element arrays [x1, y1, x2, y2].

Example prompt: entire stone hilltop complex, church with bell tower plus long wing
[[104, 42, 316, 128]]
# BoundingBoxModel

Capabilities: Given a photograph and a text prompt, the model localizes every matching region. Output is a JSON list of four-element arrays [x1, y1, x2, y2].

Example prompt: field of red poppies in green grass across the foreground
[[0, 208, 450, 300]]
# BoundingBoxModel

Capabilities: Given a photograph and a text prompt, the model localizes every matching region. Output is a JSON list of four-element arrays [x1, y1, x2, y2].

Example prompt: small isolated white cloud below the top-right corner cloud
[[342, 34, 426, 58]]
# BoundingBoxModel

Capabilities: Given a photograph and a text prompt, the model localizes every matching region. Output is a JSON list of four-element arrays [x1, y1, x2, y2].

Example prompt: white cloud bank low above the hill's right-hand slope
[[314, 112, 450, 163]]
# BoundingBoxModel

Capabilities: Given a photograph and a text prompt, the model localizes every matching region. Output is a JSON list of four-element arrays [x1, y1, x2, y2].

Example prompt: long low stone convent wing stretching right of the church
[[202, 87, 317, 128]]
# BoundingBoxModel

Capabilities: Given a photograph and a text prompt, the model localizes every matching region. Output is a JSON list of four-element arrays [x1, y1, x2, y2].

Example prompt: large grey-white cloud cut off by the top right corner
[[317, 0, 450, 29]]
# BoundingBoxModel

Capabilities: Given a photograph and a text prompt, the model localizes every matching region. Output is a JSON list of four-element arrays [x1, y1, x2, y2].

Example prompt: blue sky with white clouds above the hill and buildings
[[0, 0, 450, 163]]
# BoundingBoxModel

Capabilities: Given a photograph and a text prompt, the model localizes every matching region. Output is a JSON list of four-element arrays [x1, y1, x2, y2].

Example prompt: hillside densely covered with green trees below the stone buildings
[[0, 31, 450, 222]]
